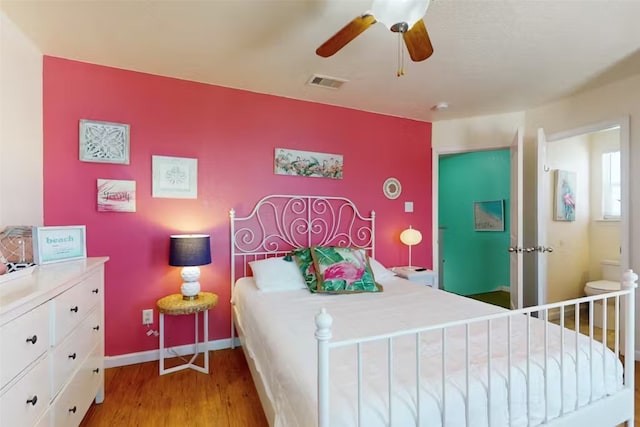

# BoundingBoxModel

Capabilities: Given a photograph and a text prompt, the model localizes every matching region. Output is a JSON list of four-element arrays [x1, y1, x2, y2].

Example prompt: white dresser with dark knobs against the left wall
[[0, 257, 109, 427]]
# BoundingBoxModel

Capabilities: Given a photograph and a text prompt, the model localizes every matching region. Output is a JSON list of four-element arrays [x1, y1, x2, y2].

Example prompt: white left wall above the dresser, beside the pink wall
[[0, 11, 43, 229]]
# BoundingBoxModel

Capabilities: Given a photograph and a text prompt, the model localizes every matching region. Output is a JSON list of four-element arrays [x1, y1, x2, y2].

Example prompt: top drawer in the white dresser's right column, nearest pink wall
[[51, 273, 104, 345]]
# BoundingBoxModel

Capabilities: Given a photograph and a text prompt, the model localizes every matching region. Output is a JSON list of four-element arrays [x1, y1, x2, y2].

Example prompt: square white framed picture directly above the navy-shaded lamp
[[151, 156, 198, 199]]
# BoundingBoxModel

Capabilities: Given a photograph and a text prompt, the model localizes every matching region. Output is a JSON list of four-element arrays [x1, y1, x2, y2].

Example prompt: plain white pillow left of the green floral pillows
[[249, 257, 307, 291]]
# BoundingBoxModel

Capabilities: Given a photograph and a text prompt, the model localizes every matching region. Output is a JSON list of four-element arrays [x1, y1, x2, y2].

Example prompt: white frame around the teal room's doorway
[[431, 139, 524, 296]]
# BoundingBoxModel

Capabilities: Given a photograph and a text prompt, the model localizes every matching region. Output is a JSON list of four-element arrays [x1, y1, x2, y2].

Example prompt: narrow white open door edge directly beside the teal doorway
[[509, 128, 523, 308]]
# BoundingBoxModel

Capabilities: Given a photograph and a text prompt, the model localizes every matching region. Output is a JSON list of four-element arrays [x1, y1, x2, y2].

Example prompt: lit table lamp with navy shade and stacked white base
[[169, 234, 211, 300]]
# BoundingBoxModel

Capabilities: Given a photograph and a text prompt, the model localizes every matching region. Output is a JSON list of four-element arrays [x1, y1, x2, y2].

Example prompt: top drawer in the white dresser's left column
[[0, 304, 49, 389]]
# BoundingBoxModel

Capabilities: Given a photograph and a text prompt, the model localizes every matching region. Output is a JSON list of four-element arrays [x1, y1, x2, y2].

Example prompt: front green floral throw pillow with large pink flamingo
[[311, 246, 382, 293]]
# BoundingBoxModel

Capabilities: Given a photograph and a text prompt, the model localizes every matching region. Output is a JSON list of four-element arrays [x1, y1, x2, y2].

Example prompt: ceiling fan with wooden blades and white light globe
[[316, 0, 433, 62]]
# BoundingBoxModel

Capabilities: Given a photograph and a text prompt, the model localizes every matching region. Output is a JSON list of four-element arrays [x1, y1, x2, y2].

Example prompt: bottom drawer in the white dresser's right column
[[53, 345, 104, 427]]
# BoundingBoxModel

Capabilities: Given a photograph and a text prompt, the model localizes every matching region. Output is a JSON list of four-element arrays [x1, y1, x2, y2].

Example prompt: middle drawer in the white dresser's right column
[[51, 308, 103, 396]]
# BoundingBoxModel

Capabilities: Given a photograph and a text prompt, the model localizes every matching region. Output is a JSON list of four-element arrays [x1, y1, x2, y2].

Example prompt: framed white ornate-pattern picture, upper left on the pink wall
[[79, 119, 129, 165]]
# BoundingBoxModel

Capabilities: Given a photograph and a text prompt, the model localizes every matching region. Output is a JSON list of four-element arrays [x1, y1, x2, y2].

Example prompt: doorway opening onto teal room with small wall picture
[[435, 148, 511, 306]]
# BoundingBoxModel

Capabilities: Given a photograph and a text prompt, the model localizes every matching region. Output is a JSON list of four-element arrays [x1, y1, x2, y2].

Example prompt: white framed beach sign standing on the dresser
[[33, 225, 87, 264]]
